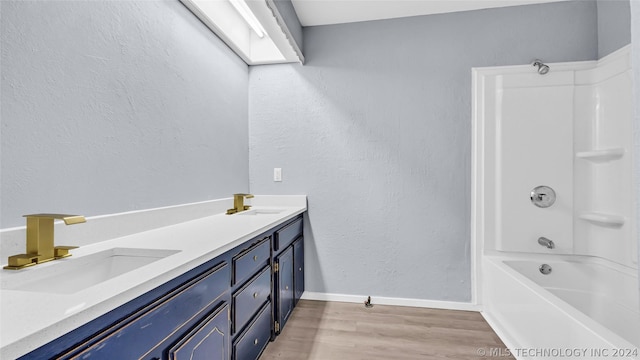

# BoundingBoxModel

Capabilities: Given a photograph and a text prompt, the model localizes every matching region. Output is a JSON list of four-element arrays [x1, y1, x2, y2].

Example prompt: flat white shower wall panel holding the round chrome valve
[[496, 72, 574, 253]]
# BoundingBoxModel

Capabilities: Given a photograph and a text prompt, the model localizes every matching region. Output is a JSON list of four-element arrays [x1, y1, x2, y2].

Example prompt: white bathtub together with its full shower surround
[[472, 46, 640, 359]]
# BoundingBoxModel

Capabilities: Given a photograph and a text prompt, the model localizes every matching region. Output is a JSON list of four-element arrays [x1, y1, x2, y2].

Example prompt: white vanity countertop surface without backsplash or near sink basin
[[0, 196, 307, 359]]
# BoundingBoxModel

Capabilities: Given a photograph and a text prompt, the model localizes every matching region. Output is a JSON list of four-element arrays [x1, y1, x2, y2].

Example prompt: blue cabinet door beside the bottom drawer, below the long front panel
[[169, 305, 230, 360]]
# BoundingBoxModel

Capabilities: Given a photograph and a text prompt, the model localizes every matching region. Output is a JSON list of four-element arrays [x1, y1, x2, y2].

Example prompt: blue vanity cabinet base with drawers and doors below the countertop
[[18, 215, 304, 360]]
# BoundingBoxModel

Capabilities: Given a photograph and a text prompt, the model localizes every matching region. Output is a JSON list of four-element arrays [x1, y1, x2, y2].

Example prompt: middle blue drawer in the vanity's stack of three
[[233, 266, 271, 333]]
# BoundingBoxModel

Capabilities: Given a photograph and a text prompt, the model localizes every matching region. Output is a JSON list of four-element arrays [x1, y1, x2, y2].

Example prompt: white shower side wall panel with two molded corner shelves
[[574, 49, 638, 267]]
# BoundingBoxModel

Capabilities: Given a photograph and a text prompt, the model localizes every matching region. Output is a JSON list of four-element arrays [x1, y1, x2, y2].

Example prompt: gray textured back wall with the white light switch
[[249, 1, 598, 301]]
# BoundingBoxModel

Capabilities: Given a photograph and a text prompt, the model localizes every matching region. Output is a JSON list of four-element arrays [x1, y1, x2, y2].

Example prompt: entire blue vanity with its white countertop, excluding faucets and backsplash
[[1, 198, 306, 360]]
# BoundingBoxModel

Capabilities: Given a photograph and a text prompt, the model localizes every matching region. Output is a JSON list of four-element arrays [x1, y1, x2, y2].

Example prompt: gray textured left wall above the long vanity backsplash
[[0, 0, 249, 228]]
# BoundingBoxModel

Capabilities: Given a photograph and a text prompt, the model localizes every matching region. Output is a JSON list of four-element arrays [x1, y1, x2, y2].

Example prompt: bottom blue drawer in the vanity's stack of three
[[233, 302, 271, 360]]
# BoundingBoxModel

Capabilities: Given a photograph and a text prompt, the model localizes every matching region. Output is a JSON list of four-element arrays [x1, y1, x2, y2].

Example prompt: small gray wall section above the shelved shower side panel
[[597, 0, 631, 58]]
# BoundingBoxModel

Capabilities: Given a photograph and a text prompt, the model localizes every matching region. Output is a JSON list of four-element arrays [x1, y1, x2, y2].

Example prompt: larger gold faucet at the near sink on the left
[[4, 214, 87, 270]]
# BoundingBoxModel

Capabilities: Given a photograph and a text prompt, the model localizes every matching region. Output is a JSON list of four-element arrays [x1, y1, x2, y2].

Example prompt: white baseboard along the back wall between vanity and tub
[[302, 291, 480, 311]]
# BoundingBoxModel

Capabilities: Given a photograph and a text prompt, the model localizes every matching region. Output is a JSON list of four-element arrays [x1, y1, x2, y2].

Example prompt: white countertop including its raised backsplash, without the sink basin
[[0, 195, 307, 359]]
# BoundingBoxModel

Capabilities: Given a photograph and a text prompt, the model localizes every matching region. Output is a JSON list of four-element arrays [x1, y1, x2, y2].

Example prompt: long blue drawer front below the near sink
[[65, 263, 230, 359]]
